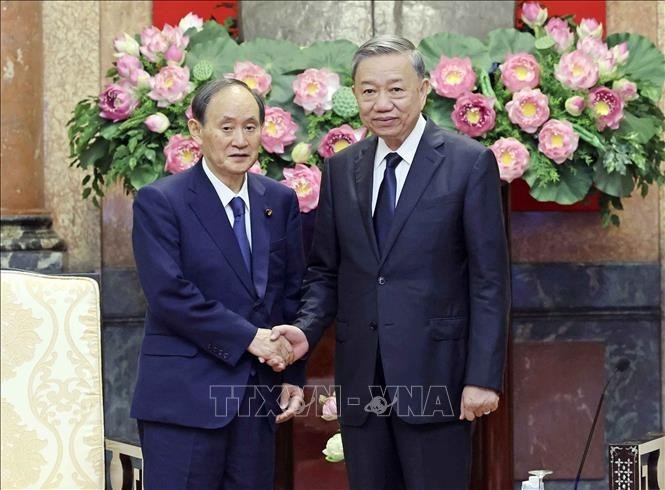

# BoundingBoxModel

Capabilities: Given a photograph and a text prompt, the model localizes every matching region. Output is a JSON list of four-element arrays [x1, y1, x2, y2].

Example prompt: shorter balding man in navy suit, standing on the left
[[132, 80, 307, 490]]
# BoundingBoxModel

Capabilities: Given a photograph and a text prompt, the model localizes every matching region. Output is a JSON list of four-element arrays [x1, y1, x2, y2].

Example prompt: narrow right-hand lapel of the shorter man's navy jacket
[[247, 173, 270, 298]]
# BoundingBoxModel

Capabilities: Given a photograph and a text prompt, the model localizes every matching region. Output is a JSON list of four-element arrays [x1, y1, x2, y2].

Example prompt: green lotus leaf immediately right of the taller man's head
[[418, 32, 492, 72]]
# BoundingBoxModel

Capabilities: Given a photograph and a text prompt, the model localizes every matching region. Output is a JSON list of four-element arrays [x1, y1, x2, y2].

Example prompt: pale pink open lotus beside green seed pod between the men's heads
[[292, 68, 340, 116]]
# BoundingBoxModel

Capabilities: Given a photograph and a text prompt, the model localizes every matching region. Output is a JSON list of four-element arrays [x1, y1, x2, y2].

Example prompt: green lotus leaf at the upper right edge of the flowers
[[607, 32, 665, 98]]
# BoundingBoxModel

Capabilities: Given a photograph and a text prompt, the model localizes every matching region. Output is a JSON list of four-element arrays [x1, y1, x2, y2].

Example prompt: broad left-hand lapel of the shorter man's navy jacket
[[186, 162, 256, 296]]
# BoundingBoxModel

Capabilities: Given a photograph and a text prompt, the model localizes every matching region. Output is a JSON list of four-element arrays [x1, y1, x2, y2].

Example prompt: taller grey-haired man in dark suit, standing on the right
[[296, 36, 509, 490]]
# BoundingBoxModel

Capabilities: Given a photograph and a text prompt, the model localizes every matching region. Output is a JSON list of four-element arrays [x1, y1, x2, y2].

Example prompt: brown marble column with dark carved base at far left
[[0, 1, 65, 272]]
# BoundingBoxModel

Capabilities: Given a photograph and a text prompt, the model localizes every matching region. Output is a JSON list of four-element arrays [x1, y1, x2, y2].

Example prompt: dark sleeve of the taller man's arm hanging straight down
[[464, 150, 510, 391]]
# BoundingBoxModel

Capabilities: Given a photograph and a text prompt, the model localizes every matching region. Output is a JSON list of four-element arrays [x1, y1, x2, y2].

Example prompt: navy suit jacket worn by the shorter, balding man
[[131, 163, 304, 428]]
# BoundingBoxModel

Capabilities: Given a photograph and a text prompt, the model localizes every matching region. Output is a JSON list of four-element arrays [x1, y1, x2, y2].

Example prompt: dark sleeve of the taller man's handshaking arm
[[296, 160, 339, 352]]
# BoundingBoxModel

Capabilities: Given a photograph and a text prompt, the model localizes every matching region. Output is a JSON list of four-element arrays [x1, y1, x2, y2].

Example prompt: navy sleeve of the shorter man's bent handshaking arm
[[132, 186, 257, 366]]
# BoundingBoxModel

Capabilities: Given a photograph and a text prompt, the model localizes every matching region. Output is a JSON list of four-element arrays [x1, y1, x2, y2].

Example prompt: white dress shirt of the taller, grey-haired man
[[372, 114, 426, 216]]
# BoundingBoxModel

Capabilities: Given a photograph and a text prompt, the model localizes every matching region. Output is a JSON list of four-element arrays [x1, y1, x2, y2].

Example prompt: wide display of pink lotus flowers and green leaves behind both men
[[69, 2, 665, 225]]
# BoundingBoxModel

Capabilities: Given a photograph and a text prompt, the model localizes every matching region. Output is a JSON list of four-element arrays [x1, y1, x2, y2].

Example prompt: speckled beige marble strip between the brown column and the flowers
[[42, 1, 101, 271]]
